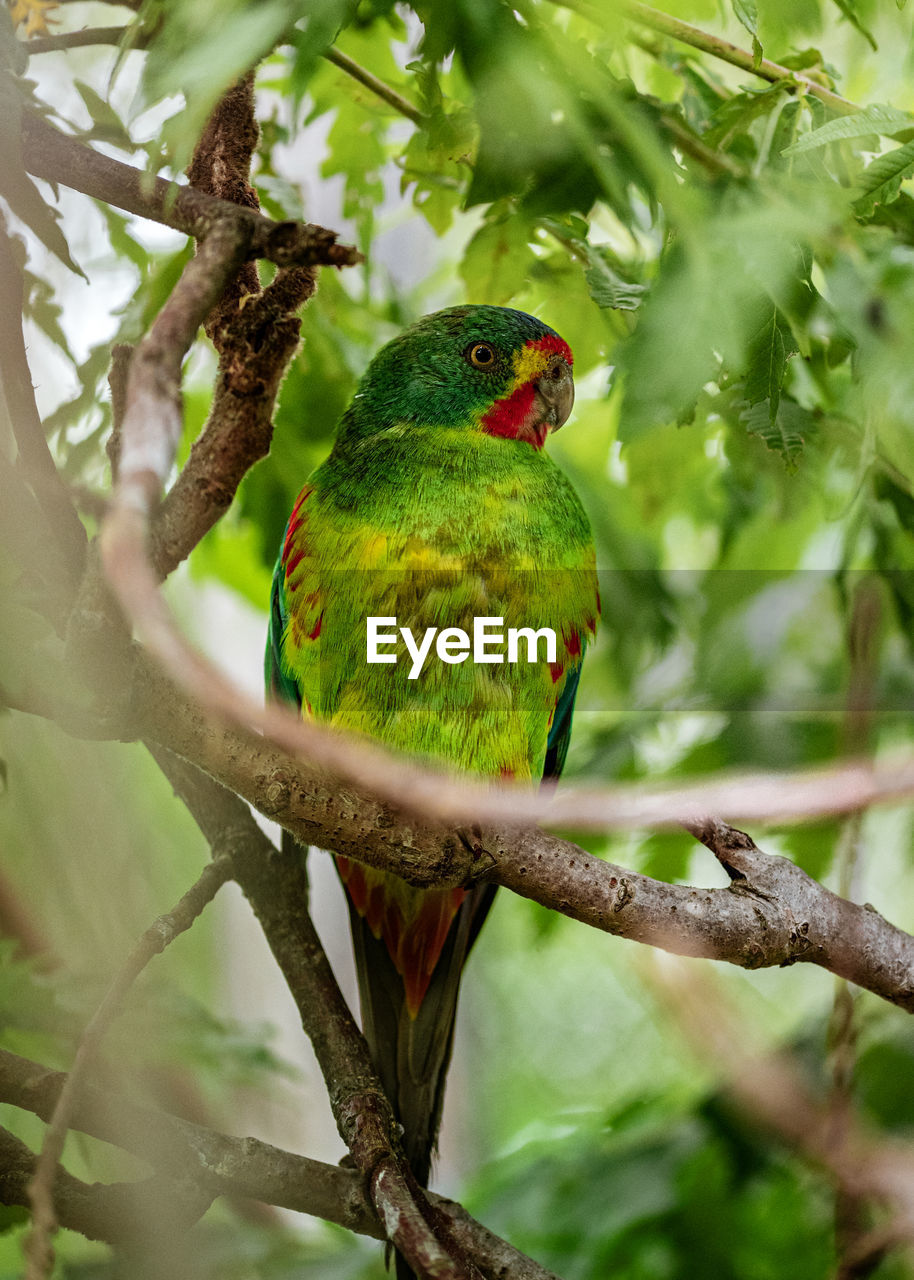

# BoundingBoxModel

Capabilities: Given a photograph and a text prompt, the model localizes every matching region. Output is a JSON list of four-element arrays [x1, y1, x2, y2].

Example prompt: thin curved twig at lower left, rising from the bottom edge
[[26, 858, 232, 1280]]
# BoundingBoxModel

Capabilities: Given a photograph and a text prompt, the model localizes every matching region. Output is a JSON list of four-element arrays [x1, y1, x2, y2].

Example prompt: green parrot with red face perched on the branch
[[266, 306, 599, 1275]]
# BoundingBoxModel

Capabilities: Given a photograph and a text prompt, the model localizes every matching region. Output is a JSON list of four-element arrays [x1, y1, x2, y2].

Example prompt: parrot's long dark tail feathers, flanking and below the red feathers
[[347, 884, 495, 1280]]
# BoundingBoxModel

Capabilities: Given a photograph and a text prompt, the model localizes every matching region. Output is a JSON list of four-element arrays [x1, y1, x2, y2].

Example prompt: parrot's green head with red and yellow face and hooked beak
[[341, 306, 575, 449]]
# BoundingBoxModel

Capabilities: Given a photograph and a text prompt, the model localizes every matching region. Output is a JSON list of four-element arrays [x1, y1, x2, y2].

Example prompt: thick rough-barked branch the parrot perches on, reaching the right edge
[[129, 673, 914, 1011]]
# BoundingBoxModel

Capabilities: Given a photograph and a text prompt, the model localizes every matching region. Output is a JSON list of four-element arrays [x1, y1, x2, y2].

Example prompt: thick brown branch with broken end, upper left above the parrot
[[23, 115, 361, 266]]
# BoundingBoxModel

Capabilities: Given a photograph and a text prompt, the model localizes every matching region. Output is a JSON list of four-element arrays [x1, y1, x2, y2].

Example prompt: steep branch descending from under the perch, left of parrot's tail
[[152, 750, 474, 1280]]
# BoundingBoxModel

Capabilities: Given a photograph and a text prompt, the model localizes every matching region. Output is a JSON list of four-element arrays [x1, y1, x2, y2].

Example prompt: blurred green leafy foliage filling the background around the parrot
[[0, 0, 914, 1280]]
